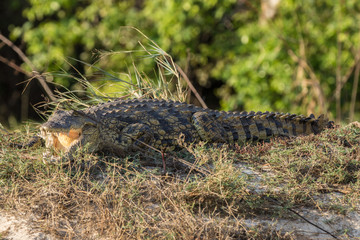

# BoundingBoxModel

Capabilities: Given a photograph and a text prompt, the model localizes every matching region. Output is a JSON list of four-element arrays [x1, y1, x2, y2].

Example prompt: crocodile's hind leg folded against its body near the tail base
[[192, 112, 234, 144]]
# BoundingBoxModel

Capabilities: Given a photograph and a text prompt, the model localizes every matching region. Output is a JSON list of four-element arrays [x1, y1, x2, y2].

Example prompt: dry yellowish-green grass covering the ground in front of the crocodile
[[0, 123, 360, 239]]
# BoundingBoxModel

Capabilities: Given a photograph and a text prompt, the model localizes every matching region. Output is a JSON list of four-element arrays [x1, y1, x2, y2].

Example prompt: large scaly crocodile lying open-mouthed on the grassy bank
[[40, 99, 331, 156]]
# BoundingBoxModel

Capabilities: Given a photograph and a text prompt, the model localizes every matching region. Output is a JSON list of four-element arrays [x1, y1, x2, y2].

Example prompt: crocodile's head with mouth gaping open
[[40, 110, 96, 151]]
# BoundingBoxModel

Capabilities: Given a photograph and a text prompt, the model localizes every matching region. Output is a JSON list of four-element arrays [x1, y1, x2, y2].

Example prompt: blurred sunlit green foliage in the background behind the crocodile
[[10, 0, 360, 119]]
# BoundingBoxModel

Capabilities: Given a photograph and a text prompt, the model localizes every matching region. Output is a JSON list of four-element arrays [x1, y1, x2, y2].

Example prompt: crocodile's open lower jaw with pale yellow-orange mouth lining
[[40, 126, 82, 152]]
